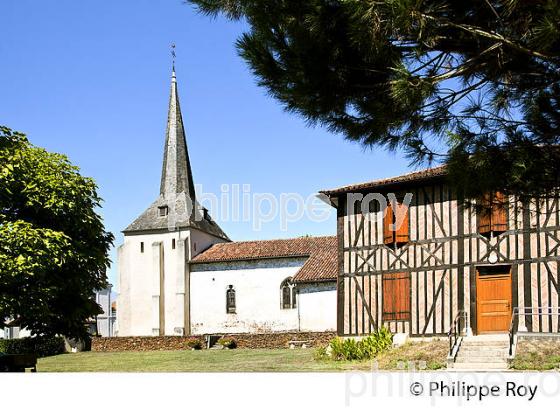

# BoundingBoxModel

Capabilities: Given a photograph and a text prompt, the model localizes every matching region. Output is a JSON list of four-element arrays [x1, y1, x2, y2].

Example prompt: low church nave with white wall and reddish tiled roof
[[190, 237, 337, 334]]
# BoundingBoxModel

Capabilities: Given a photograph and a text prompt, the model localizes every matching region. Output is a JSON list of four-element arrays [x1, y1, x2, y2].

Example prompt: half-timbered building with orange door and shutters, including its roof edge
[[323, 167, 560, 336]]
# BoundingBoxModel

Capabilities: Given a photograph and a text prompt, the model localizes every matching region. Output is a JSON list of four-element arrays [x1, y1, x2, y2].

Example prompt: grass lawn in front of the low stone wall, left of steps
[[37, 342, 447, 372]]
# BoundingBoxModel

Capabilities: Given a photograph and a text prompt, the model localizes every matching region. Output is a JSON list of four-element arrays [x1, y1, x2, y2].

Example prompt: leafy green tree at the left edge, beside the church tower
[[0, 127, 113, 337]]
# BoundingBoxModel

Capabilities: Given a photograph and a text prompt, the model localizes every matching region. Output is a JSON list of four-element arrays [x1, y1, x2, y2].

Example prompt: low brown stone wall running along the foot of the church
[[91, 332, 336, 352]]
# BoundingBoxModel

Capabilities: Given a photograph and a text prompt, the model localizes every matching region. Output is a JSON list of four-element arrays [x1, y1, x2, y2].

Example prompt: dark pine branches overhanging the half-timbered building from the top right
[[189, 0, 560, 196]]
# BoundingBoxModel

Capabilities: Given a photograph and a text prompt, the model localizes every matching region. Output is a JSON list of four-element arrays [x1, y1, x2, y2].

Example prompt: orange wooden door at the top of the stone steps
[[476, 266, 511, 334]]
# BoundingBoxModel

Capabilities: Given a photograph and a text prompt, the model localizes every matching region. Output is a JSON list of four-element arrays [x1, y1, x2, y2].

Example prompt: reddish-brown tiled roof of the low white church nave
[[191, 236, 338, 282]]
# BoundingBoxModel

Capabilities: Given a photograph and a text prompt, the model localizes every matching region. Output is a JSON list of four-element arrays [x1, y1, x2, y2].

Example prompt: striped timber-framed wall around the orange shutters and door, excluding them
[[324, 178, 560, 336]]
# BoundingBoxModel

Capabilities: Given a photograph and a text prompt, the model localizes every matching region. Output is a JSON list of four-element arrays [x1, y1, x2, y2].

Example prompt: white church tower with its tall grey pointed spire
[[117, 71, 229, 336]]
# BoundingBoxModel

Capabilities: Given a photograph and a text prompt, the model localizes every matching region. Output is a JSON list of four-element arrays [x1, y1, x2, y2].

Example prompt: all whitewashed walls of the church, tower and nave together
[[116, 229, 336, 336]]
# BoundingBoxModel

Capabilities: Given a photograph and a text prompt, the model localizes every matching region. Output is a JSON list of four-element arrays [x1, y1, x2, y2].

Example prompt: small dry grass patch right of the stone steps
[[511, 340, 560, 370]]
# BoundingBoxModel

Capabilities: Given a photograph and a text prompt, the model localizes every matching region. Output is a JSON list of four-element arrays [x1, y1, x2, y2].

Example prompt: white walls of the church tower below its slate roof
[[117, 229, 223, 336]]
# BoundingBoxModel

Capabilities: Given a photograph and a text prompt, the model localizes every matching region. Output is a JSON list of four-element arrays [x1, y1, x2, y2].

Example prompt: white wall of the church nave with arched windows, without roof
[[190, 258, 336, 334]]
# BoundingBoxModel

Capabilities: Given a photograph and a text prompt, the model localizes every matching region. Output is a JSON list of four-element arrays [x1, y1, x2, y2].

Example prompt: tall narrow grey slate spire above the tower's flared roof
[[160, 66, 195, 204]]
